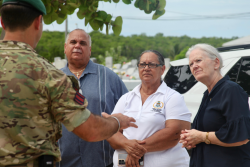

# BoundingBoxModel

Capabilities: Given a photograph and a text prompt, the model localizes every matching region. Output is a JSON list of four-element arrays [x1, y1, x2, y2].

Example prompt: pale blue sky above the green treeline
[[29, 0, 250, 38]]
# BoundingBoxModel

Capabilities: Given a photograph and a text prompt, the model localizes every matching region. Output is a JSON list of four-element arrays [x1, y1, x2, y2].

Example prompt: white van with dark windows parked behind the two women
[[164, 44, 250, 122]]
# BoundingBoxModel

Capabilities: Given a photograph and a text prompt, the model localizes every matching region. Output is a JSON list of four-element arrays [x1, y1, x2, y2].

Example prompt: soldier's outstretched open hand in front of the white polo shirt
[[102, 112, 138, 130]]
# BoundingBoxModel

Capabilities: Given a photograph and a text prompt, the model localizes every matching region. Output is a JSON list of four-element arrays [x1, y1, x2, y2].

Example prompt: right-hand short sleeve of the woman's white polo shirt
[[165, 93, 192, 122]]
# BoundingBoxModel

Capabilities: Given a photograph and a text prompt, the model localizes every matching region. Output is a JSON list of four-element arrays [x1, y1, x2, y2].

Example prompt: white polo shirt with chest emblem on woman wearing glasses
[[112, 82, 191, 167]]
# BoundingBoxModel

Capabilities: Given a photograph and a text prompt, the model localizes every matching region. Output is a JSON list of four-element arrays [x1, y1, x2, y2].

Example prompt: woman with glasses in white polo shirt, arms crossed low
[[108, 50, 191, 167]]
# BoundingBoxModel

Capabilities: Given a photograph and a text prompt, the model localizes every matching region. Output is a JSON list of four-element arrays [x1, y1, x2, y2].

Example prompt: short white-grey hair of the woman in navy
[[186, 43, 223, 69]]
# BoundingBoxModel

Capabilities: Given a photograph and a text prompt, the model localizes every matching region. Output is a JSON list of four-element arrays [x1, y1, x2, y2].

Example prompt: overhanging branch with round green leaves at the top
[[0, 0, 166, 35]]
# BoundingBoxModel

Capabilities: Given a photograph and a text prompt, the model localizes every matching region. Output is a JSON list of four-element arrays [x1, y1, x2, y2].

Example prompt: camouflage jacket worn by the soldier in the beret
[[0, 41, 90, 166]]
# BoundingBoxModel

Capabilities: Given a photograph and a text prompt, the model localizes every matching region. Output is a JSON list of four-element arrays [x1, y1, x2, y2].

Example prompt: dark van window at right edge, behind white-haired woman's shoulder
[[227, 57, 250, 96]]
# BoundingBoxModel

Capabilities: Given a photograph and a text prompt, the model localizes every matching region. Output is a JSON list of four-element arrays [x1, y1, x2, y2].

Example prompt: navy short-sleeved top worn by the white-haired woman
[[190, 76, 250, 167]]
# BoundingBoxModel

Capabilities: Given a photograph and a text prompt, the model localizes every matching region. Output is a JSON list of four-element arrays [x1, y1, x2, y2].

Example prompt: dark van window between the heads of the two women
[[164, 65, 197, 94]]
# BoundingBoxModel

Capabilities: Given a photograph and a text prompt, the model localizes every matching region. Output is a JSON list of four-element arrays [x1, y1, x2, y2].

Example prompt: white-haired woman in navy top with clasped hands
[[180, 44, 250, 167]]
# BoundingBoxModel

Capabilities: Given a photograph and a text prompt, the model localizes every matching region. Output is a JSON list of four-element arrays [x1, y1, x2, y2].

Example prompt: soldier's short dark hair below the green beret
[[0, 5, 41, 32]]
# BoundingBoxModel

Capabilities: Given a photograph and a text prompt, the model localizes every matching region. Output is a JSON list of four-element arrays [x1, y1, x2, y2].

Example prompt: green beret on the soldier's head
[[2, 0, 46, 15]]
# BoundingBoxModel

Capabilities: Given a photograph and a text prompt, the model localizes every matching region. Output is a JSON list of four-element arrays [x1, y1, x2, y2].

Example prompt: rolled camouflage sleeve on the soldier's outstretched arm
[[45, 69, 90, 131]]
